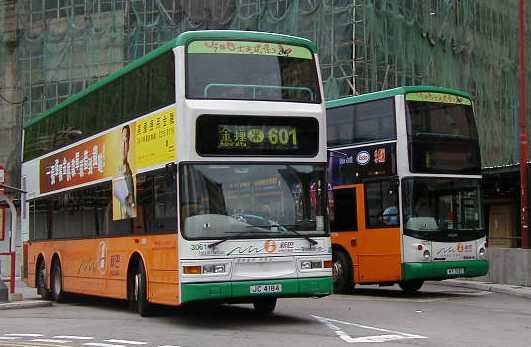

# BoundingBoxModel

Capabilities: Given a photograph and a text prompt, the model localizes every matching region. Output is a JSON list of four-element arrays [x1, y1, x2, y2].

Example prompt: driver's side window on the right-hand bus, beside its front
[[365, 180, 400, 228]]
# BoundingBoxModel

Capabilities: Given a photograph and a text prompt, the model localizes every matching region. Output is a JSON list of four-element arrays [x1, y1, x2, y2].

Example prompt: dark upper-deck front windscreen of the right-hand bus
[[406, 93, 481, 174]]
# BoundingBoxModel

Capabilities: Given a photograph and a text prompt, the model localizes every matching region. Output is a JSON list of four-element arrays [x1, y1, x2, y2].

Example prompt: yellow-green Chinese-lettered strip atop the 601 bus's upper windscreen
[[188, 40, 313, 59]]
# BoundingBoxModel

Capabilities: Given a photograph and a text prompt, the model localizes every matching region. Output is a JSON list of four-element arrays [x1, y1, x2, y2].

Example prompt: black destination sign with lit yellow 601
[[196, 115, 319, 156]]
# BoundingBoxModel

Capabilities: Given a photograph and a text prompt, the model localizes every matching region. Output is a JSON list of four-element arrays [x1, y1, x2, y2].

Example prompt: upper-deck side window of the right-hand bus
[[326, 98, 396, 146]]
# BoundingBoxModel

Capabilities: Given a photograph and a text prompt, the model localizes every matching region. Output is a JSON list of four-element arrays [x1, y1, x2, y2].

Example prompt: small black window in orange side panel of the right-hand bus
[[330, 188, 358, 232]]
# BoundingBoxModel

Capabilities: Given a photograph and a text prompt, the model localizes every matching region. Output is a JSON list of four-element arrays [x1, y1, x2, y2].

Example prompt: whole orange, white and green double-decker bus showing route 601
[[22, 31, 332, 315]]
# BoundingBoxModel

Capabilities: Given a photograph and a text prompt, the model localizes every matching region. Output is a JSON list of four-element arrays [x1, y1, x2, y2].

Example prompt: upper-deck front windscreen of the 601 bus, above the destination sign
[[186, 41, 321, 103]]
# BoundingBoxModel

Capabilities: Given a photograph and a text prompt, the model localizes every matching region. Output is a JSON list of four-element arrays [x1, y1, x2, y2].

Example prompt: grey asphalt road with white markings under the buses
[[0, 284, 531, 347]]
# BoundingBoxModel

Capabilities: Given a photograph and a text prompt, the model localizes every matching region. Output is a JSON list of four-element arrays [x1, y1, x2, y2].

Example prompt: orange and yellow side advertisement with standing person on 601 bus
[[39, 109, 176, 200]]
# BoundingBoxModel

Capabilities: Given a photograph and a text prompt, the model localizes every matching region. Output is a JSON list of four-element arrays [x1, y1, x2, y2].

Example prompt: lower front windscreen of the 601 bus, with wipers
[[180, 164, 326, 240]]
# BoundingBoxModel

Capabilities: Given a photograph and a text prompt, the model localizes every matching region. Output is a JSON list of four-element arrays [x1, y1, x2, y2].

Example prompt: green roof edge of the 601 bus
[[24, 30, 317, 128]]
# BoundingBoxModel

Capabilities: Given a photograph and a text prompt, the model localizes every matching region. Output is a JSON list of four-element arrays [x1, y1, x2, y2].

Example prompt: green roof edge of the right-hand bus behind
[[326, 86, 472, 108]]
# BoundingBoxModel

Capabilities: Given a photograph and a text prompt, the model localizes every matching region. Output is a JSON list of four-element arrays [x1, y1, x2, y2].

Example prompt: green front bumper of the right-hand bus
[[402, 260, 489, 281]]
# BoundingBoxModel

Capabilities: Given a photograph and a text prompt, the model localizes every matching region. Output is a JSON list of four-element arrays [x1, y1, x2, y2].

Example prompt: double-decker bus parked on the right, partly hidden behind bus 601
[[327, 86, 488, 292]]
